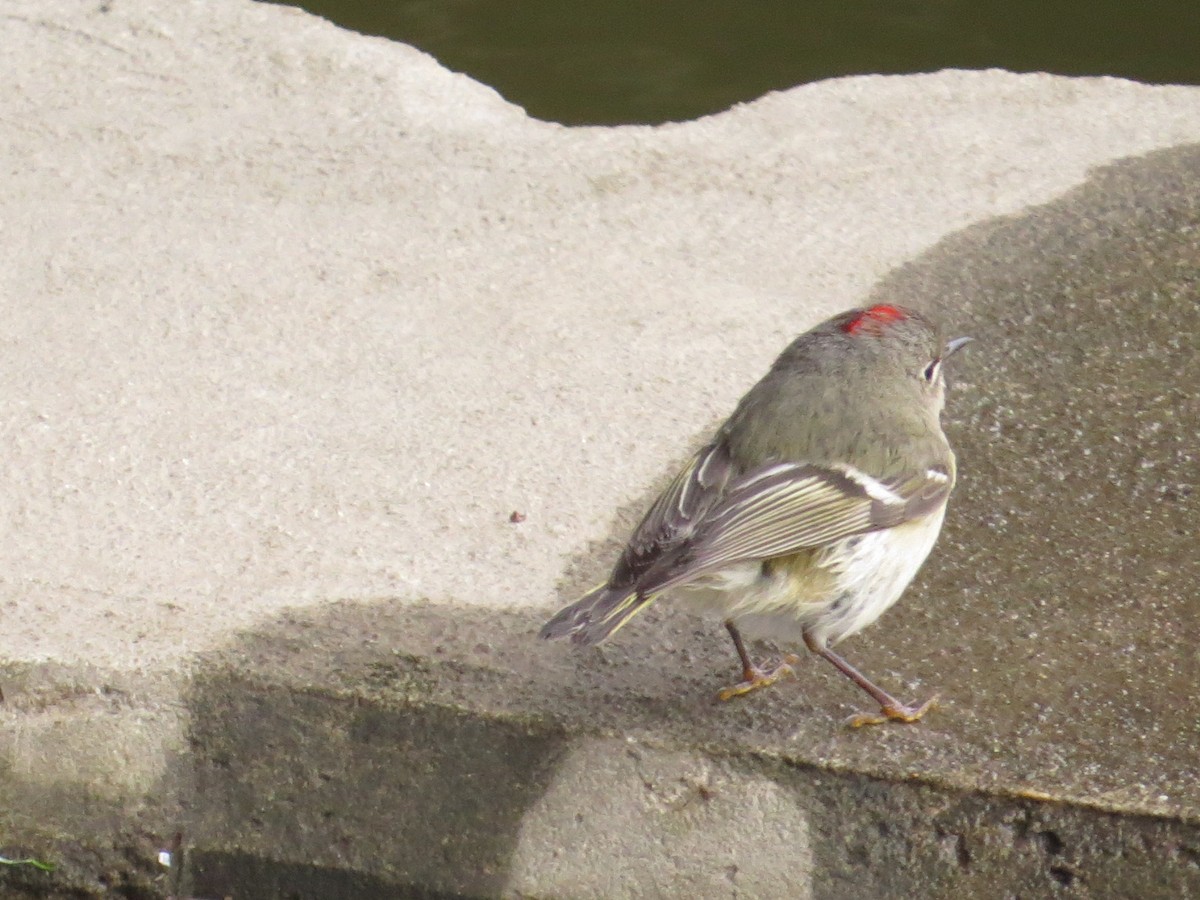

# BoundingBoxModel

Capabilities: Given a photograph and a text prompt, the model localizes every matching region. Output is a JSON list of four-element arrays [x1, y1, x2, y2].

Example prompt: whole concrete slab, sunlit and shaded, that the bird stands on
[[0, 0, 1200, 898]]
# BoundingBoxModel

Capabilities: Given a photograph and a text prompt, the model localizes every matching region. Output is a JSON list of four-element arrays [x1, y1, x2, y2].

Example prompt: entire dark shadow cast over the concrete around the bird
[[169, 148, 1200, 898]]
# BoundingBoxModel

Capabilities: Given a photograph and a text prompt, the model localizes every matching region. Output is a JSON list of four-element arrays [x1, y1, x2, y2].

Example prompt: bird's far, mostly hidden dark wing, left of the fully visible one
[[610, 439, 733, 587]]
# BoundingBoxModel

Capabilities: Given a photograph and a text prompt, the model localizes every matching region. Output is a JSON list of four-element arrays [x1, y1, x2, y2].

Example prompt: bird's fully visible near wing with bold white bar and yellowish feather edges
[[638, 463, 954, 593]]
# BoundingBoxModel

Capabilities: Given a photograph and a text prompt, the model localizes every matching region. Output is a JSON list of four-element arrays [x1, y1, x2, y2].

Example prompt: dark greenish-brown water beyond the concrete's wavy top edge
[[267, 0, 1200, 125]]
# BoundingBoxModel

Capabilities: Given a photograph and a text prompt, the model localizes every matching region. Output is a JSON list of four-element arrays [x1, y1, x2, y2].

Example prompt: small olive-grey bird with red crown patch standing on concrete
[[541, 304, 971, 727]]
